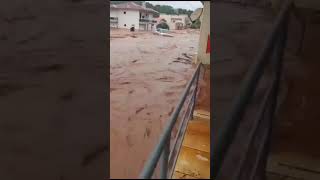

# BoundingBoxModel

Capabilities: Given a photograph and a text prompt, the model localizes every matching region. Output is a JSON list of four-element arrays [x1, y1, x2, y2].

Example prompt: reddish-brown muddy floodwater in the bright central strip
[[110, 29, 199, 178]]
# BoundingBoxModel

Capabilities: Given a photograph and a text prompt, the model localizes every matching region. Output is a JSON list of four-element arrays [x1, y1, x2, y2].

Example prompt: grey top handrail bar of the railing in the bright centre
[[140, 64, 200, 179]]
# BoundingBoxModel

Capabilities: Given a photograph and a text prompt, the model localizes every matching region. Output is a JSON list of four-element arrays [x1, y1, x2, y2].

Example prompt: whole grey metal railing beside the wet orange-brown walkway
[[140, 63, 201, 179]]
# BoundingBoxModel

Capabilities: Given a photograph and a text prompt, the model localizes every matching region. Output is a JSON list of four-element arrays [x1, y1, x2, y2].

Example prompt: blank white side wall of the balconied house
[[118, 10, 139, 29]]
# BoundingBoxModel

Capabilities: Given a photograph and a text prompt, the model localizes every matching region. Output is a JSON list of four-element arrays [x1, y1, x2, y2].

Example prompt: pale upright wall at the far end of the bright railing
[[197, 1, 210, 64]]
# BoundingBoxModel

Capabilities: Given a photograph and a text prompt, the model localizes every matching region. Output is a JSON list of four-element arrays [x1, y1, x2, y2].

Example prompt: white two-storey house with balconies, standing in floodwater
[[110, 2, 159, 30]]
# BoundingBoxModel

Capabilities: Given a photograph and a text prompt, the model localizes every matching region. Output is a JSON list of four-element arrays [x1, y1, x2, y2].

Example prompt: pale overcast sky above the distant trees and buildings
[[147, 1, 203, 10]]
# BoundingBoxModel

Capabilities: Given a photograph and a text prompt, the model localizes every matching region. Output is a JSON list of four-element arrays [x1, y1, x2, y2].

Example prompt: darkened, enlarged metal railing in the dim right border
[[215, 0, 293, 180]]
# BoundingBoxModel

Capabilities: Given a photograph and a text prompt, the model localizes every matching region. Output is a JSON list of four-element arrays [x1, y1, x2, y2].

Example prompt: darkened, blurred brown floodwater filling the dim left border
[[0, 0, 109, 180]]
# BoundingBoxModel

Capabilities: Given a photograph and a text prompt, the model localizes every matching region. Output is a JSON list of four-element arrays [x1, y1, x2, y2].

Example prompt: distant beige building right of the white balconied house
[[157, 14, 191, 30]]
